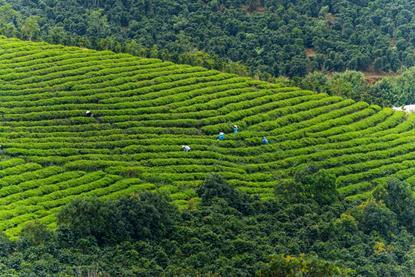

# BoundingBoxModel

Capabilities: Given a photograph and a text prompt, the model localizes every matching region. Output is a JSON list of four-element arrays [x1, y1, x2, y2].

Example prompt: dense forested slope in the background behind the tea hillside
[[0, 0, 415, 76]]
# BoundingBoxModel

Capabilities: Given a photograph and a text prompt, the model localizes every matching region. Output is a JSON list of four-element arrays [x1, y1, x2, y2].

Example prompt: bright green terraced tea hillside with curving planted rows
[[0, 38, 415, 236]]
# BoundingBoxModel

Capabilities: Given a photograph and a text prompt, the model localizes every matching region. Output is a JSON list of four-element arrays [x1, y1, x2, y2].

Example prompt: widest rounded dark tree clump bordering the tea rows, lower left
[[58, 193, 177, 245]]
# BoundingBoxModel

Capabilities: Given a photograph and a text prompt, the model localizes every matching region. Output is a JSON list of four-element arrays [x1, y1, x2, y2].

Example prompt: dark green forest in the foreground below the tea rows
[[0, 170, 415, 276]]
